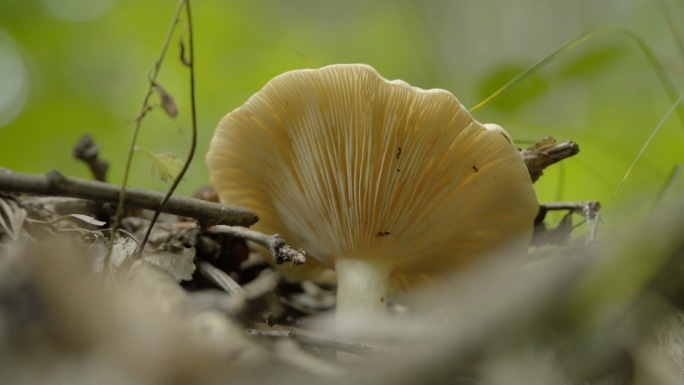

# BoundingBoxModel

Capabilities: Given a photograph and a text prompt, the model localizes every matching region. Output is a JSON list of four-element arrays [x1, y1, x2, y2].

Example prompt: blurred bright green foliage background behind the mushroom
[[0, 0, 684, 228]]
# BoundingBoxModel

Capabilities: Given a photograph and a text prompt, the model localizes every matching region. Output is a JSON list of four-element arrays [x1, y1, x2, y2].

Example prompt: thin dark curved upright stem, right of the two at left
[[139, 0, 197, 251]]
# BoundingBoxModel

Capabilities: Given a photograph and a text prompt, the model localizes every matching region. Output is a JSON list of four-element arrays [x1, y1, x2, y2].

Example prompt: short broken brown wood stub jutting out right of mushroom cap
[[522, 136, 579, 182]]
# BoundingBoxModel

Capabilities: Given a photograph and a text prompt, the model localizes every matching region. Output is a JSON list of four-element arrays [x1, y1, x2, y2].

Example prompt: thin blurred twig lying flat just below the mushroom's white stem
[[247, 328, 401, 354]]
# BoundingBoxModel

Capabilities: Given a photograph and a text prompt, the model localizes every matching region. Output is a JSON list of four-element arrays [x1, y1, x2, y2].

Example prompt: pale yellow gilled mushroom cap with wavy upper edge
[[206, 64, 538, 289]]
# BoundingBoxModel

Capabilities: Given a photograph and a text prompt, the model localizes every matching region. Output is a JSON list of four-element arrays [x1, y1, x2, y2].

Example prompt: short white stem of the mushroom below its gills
[[335, 258, 390, 319]]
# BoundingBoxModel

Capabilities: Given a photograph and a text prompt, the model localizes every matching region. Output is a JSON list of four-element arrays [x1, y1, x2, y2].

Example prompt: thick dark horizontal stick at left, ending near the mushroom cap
[[0, 170, 259, 228]]
